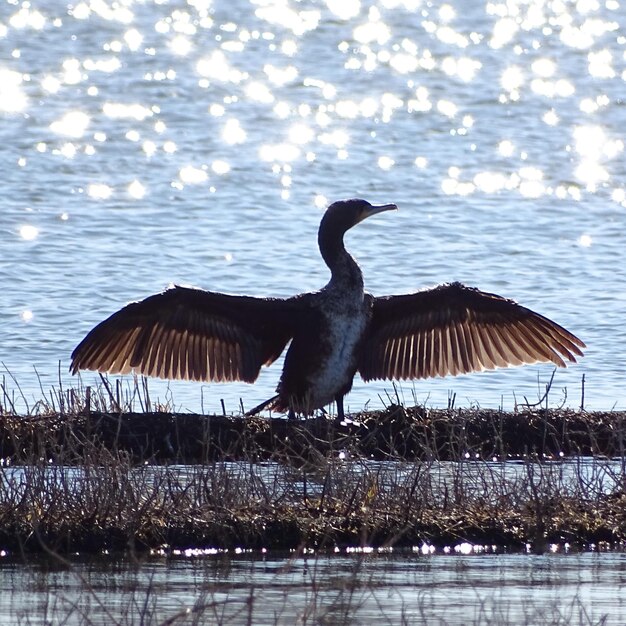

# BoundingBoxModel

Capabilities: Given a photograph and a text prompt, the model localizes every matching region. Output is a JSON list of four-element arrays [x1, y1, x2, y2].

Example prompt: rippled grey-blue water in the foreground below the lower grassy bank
[[0, 545, 626, 625]]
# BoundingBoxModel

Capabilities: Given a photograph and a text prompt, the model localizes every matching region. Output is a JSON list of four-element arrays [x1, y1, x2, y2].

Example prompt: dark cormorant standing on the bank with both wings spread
[[70, 198, 586, 422]]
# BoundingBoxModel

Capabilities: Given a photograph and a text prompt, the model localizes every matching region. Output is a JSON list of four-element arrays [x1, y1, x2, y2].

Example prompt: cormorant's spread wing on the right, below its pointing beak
[[359, 283, 585, 380]]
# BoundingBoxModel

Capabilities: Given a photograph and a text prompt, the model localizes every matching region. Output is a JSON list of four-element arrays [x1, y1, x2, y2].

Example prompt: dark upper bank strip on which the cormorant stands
[[0, 406, 626, 464]]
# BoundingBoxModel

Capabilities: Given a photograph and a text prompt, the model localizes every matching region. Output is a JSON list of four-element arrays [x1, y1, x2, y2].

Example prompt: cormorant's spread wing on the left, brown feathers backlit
[[71, 286, 300, 382]]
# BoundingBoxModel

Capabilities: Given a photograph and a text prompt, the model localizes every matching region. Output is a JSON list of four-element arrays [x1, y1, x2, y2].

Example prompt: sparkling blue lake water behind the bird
[[0, 0, 626, 411]]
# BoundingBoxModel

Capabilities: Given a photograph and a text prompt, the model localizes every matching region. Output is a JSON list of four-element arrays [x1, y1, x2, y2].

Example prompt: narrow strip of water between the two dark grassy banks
[[0, 451, 626, 498]]
